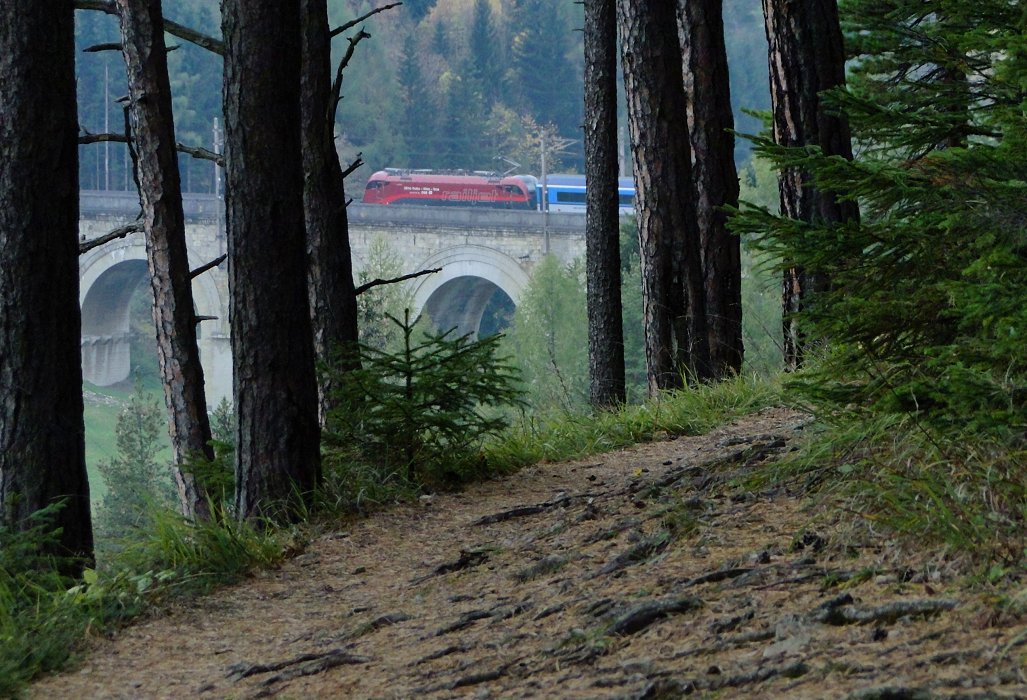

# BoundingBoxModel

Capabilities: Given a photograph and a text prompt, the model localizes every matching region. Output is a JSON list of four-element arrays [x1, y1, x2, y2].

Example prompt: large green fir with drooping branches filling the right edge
[[740, 0, 1027, 433]]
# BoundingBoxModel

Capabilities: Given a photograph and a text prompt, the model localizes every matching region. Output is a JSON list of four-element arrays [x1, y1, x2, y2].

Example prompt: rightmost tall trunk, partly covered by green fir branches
[[763, 0, 860, 370]]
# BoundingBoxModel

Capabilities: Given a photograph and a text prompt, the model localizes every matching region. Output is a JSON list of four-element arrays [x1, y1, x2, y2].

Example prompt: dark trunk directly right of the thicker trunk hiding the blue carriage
[[678, 0, 744, 378]]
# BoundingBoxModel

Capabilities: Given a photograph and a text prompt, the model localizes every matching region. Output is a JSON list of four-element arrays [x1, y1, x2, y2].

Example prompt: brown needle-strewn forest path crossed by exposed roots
[[30, 409, 1027, 700]]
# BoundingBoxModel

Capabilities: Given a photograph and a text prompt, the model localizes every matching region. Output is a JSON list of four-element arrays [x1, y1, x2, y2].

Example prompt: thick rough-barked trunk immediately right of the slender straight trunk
[[617, 0, 710, 394]]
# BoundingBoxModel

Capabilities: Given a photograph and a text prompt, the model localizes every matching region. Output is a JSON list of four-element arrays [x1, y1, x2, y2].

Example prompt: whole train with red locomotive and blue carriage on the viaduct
[[364, 168, 635, 215]]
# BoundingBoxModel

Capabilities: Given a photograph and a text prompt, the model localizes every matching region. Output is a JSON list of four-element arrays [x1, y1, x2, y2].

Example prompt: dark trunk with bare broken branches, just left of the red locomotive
[[300, 0, 359, 422]]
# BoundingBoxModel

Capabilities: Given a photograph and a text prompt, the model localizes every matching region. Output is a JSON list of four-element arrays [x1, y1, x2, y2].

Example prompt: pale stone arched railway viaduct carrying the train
[[79, 191, 584, 404]]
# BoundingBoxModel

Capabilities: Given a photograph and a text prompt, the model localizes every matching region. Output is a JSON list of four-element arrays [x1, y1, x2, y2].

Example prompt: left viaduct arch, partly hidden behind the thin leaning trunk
[[79, 234, 229, 386]]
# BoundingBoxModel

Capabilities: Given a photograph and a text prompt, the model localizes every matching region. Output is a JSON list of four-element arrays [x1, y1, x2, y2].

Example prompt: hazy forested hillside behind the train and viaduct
[[76, 0, 769, 193]]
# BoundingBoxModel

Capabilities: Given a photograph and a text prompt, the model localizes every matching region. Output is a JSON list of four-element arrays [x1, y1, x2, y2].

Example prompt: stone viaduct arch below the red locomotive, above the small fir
[[414, 245, 530, 335]]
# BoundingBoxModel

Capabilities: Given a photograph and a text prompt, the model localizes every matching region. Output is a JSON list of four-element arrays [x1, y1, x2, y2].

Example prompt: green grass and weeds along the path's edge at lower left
[[0, 500, 289, 697]]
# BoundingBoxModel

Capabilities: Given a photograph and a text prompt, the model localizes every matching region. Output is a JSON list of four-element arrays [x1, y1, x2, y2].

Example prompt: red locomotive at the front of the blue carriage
[[364, 168, 538, 209]]
